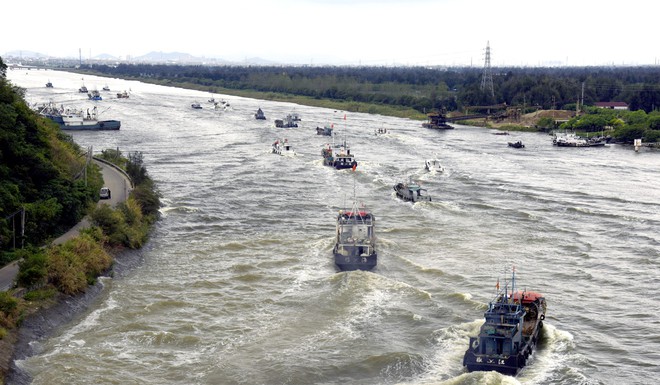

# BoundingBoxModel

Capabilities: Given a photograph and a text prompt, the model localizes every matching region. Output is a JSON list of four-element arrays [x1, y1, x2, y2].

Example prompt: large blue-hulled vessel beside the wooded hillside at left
[[39, 104, 121, 130]]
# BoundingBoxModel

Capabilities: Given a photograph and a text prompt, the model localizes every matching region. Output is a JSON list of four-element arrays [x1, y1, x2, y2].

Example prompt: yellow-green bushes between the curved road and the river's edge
[[17, 150, 160, 294]]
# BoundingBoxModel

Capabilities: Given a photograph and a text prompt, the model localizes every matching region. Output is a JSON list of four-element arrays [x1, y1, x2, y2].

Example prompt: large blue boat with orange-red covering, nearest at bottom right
[[463, 269, 547, 376]]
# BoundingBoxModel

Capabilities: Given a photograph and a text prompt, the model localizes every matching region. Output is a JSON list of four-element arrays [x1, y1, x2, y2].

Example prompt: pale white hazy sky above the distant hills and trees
[[0, 0, 660, 67]]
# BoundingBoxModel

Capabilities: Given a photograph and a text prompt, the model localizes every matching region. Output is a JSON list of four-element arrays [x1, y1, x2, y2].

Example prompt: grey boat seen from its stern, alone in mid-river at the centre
[[332, 201, 378, 271]]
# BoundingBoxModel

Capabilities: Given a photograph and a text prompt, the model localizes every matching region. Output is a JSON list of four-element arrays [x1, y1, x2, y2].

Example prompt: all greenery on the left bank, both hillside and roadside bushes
[[0, 59, 160, 382]]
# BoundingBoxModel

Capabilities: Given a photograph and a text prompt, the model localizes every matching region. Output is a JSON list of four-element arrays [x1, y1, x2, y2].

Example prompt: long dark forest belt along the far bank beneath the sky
[[83, 64, 660, 112]]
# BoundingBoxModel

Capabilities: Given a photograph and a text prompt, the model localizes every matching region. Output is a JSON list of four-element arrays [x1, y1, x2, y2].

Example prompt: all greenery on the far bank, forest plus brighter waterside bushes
[[76, 64, 660, 143]]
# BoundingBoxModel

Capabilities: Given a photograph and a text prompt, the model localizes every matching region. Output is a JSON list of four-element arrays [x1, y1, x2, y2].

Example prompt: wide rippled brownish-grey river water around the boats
[[8, 70, 660, 385]]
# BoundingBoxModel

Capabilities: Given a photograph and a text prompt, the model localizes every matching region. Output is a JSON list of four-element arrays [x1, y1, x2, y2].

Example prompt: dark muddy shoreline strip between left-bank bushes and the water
[[5, 249, 144, 385]]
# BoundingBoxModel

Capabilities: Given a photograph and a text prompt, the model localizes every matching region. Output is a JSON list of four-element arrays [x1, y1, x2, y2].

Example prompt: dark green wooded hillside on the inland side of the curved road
[[0, 59, 103, 265]]
